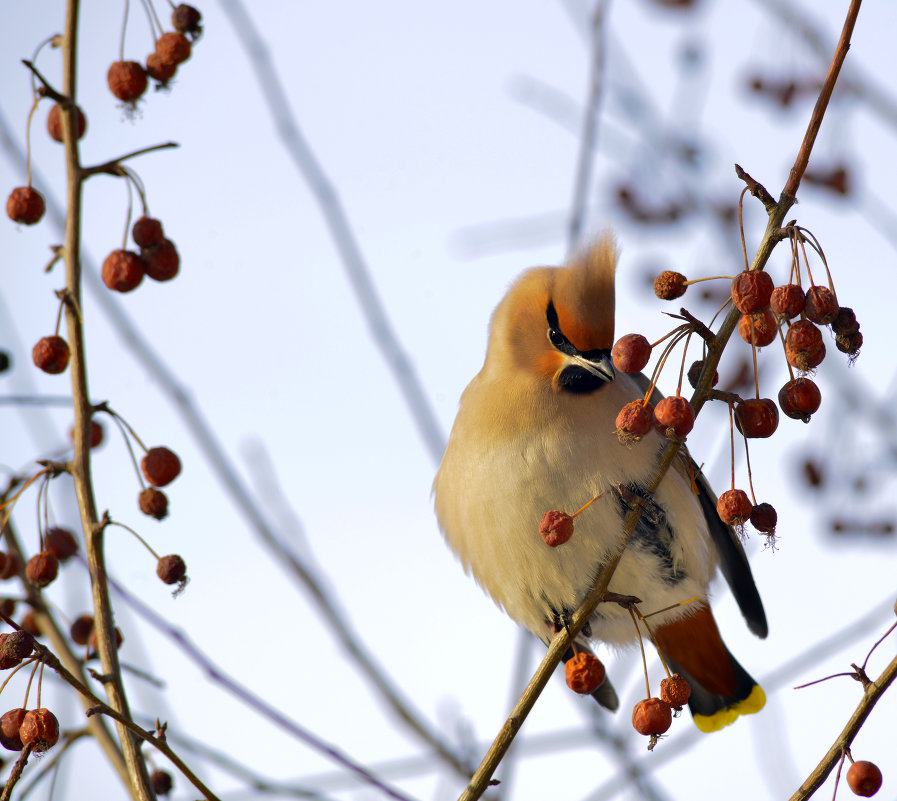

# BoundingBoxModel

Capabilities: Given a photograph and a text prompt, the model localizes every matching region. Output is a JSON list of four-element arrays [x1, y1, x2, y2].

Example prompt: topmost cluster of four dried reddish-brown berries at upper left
[[106, 3, 202, 103]]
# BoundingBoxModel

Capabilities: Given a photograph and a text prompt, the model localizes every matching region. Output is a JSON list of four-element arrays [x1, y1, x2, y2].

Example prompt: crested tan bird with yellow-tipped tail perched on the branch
[[433, 234, 768, 732]]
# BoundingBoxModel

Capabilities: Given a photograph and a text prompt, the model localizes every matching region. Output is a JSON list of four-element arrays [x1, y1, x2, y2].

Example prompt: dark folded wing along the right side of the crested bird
[[632, 373, 769, 638]]
